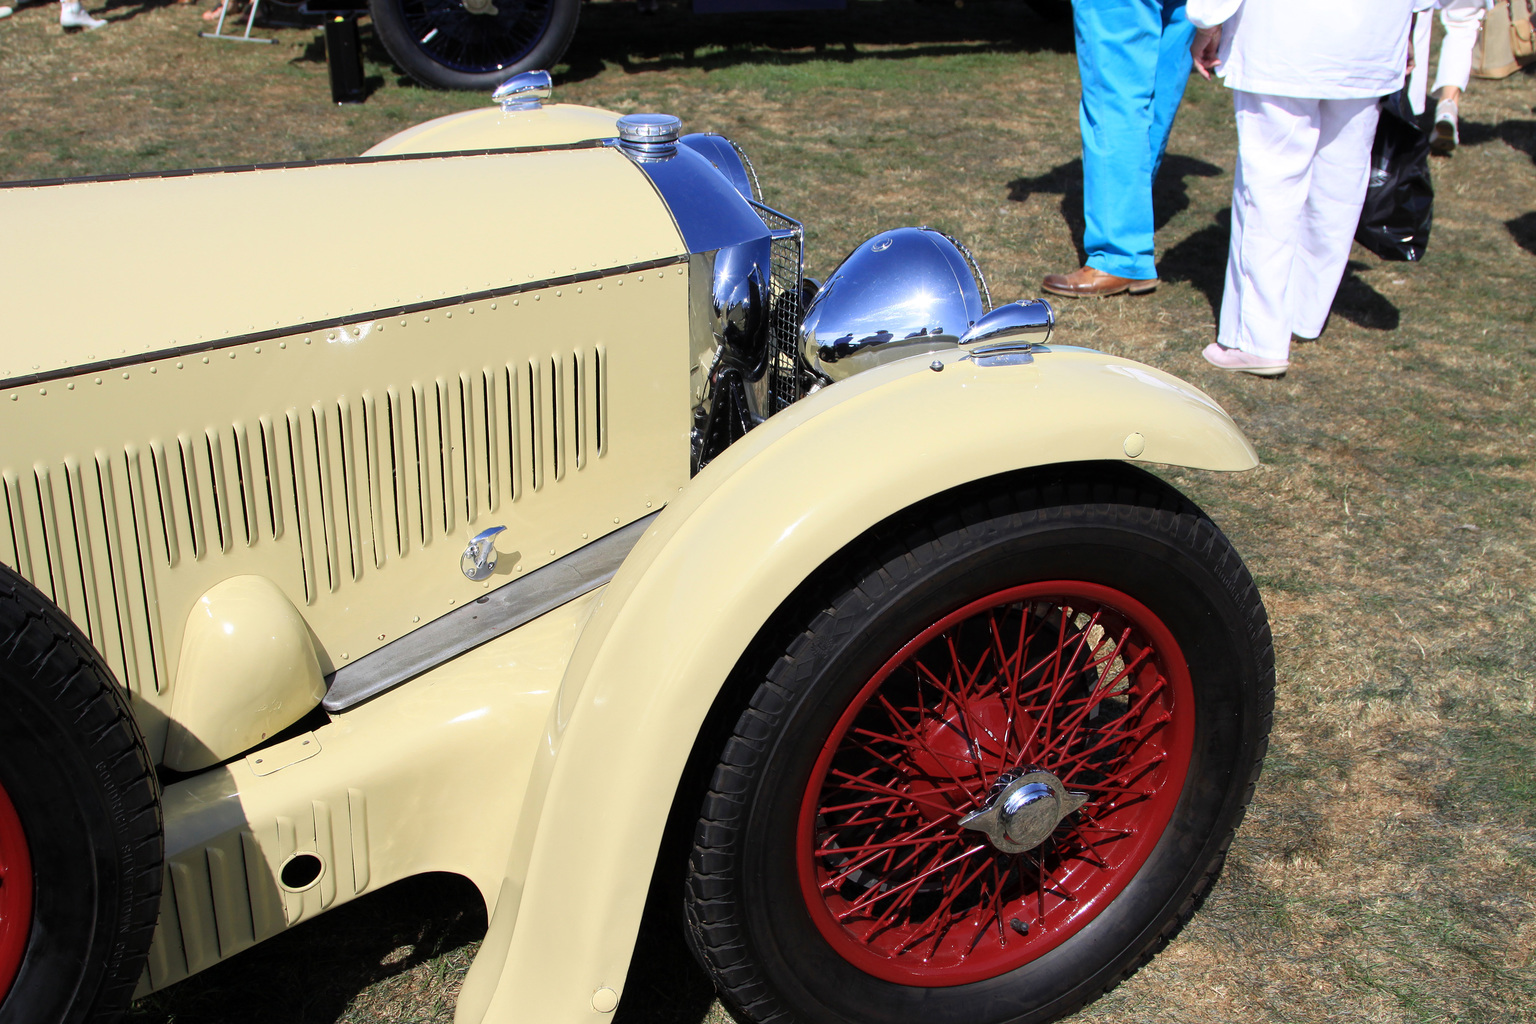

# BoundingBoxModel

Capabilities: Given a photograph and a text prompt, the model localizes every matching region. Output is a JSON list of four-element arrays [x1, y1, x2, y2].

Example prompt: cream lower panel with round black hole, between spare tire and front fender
[[138, 594, 596, 995]]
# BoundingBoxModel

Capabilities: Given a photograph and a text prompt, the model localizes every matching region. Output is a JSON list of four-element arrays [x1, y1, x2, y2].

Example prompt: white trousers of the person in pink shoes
[[1217, 89, 1376, 359]]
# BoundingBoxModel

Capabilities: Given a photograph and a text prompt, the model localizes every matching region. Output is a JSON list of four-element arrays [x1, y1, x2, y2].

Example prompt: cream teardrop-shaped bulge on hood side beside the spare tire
[[164, 576, 326, 772]]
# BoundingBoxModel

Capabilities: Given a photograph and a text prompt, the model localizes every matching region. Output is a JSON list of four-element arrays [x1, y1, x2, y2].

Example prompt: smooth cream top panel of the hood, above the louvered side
[[0, 147, 684, 382]]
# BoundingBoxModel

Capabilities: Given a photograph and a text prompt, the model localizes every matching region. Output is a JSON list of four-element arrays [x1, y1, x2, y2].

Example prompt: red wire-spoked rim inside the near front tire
[[797, 580, 1195, 987]]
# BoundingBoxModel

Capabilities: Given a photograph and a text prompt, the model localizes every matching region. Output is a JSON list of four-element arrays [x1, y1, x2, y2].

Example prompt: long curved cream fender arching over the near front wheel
[[456, 348, 1258, 1024]]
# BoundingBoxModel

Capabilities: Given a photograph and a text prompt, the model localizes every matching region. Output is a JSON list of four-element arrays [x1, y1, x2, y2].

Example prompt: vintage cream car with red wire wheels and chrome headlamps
[[0, 75, 1273, 1024]]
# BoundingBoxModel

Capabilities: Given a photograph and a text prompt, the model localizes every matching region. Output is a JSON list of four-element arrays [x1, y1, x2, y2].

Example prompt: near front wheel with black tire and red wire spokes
[[684, 467, 1275, 1024]]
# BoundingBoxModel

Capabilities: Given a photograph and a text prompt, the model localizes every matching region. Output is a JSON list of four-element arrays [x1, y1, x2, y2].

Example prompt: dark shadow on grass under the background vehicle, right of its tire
[[559, 0, 1072, 81]]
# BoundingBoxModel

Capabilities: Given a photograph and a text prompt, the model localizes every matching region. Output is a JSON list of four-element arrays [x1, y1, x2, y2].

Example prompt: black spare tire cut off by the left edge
[[0, 565, 163, 1024]]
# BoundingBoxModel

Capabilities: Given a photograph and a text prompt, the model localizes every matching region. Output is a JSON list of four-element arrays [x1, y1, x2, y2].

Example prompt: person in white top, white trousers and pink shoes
[[1187, 0, 1415, 376]]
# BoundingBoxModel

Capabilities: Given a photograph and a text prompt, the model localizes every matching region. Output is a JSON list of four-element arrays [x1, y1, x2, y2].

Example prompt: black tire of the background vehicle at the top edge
[[369, 0, 581, 92]]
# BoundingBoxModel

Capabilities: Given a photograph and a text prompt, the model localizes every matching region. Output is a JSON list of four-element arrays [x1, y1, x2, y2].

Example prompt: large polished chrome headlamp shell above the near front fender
[[800, 227, 986, 381]]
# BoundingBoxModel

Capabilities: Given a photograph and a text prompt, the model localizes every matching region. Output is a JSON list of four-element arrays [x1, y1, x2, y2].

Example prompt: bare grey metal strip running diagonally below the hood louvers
[[321, 513, 660, 712]]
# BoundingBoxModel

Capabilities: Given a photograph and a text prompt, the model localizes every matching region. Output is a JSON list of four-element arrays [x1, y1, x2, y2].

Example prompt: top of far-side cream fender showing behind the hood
[[362, 103, 621, 157]]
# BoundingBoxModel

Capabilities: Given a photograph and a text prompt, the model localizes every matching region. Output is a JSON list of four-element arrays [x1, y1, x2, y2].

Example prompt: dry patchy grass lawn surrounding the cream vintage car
[[0, 0, 1536, 1024]]
